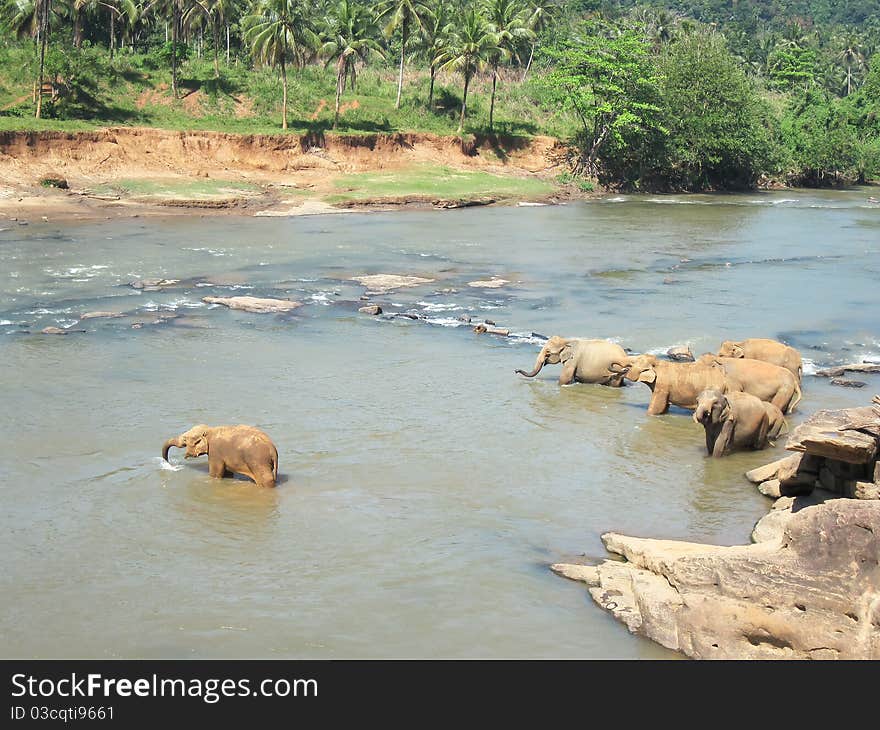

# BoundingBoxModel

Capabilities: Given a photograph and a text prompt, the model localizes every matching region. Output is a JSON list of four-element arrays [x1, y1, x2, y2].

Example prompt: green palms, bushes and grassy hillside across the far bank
[[0, 0, 880, 190]]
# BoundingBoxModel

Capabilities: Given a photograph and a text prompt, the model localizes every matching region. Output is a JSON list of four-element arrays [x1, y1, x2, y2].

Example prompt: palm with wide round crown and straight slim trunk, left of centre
[[242, 0, 317, 129]]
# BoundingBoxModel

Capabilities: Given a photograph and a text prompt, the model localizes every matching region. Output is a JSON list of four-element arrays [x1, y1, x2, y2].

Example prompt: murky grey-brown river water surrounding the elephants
[[0, 189, 880, 658]]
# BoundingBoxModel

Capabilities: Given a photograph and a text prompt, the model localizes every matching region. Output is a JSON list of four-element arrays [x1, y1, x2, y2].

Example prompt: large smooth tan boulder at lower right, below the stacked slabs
[[553, 499, 880, 659]]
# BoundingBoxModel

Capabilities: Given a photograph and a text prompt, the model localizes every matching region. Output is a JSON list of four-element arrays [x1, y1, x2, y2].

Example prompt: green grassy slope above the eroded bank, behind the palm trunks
[[0, 42, 576, 137]]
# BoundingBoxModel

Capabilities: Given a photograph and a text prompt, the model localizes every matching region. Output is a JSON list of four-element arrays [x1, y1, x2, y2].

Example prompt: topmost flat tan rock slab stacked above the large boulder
[[785, 406, 880, 464]]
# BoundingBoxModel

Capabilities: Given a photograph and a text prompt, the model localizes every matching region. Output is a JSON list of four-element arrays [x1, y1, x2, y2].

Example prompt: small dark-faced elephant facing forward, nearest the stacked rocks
[[693, 390, 788, 458]]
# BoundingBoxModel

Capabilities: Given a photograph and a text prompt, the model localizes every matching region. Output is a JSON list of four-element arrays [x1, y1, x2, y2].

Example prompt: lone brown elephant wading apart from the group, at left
[[162, 423, 278, 487]]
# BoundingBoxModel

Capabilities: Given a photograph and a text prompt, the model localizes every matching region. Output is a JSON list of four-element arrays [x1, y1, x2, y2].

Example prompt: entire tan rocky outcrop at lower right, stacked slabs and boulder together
[[552, 396, 880, 659]]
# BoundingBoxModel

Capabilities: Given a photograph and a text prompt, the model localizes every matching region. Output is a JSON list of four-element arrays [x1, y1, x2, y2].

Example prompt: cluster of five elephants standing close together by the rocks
[[516, 337, 803, 457]]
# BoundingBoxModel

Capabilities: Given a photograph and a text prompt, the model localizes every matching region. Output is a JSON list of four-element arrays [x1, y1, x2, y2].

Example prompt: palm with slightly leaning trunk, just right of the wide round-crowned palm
[[321, 0, 384, 129]]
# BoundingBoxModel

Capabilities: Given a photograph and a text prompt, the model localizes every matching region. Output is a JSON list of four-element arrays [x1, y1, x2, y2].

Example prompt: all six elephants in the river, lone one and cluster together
[[162, 337, 803, 487]]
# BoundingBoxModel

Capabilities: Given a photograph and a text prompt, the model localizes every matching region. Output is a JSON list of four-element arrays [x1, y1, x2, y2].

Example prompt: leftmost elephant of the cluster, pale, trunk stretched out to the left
[[516, 335, 627, 388]]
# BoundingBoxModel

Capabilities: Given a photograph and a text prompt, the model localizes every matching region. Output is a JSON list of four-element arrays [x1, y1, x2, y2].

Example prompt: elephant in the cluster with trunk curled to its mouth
[[609, 355, 742, 416]]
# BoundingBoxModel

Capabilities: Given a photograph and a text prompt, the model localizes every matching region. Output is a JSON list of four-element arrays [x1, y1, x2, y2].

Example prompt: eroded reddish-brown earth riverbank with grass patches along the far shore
[[0, 127, 586, 222]]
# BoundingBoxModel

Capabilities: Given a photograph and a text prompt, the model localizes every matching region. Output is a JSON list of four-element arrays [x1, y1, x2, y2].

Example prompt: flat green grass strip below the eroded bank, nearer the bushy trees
[[324, 165, 553, 203]]
